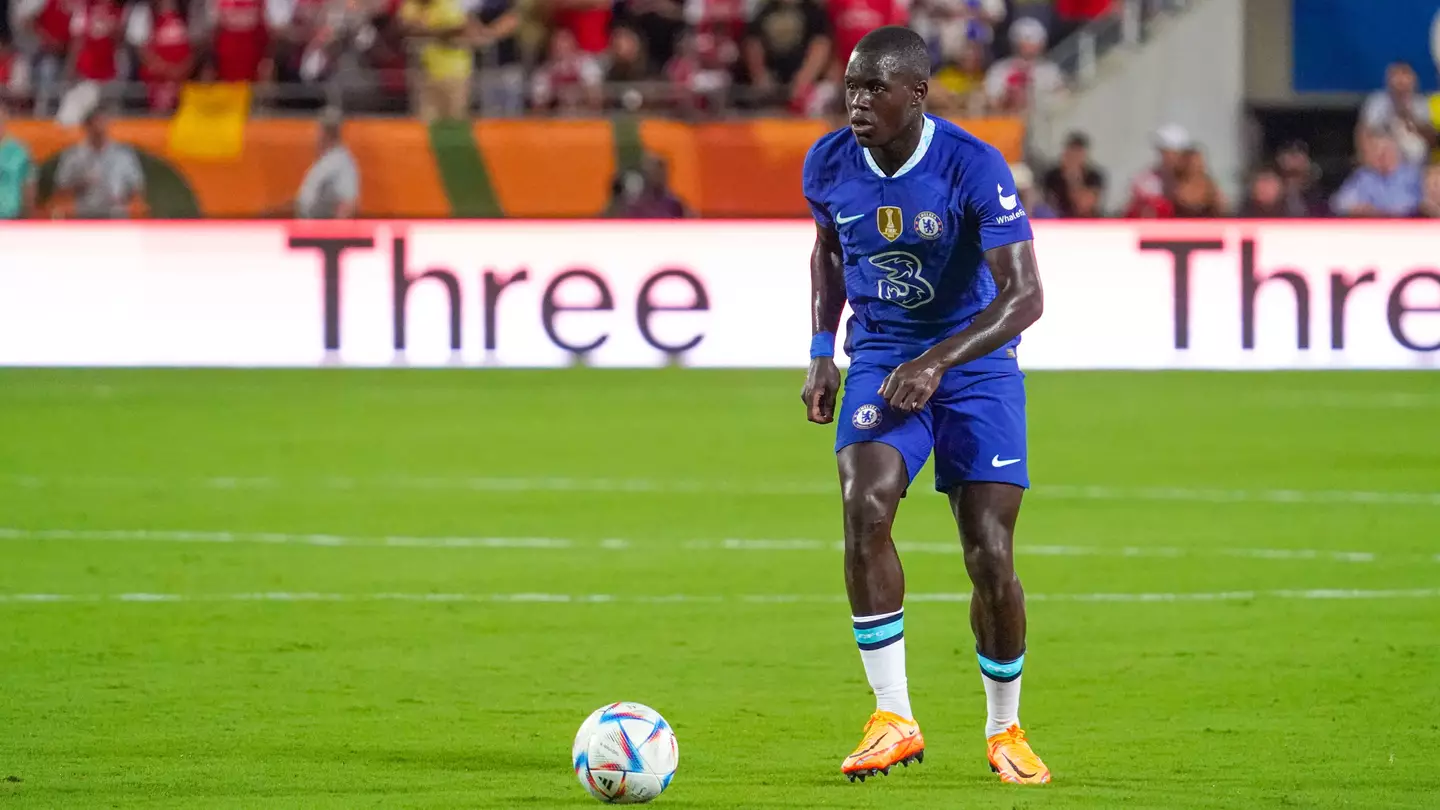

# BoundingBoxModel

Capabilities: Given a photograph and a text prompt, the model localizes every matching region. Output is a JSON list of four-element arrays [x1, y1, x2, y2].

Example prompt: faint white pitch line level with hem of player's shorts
[[0, 474, 1440, 506]]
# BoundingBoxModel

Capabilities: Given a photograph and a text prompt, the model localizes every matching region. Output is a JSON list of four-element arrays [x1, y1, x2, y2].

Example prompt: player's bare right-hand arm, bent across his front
[[880, 239, 1044, 412]]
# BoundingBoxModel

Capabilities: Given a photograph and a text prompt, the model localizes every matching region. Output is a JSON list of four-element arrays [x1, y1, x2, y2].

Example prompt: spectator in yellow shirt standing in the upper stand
[[400, 0, 475, 121]]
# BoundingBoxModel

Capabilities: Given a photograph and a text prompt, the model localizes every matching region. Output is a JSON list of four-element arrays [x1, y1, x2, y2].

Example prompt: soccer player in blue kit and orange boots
[[802, 26, 1050, 784]]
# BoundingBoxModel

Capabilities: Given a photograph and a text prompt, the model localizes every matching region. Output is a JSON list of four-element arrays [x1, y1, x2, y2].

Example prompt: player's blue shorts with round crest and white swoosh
[[835, 365, 1030, 491]]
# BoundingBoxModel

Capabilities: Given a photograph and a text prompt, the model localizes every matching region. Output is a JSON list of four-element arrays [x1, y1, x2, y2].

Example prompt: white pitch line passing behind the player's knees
[[0, 528, 1399, 562]]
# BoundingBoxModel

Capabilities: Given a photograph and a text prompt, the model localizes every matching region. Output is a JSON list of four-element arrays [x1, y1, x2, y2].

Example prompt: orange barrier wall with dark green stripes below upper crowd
[[10, 118, 1024, 218]]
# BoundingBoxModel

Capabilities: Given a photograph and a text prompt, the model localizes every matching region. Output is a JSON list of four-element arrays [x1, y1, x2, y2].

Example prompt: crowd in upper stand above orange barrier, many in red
[[0, 0, 1116, 120]]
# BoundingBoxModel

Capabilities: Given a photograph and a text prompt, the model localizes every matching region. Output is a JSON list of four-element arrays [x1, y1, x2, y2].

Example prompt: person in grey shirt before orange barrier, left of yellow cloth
[[55, 110, 145, 219]]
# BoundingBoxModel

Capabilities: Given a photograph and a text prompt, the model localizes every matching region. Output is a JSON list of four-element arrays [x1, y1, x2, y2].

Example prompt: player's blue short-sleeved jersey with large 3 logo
[[804, 115, 1031, 370]]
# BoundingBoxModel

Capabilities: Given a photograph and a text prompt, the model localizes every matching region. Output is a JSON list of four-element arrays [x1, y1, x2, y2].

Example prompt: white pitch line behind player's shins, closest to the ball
[[0, 588, 1440, 604]]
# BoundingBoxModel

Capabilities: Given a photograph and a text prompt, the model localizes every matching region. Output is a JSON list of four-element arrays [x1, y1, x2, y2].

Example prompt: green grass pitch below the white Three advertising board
[[0, 370, 1440, 809]]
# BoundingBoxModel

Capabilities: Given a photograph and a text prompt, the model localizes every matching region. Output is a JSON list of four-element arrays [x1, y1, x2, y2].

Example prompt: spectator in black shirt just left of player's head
[[744, 0, 831, 114]]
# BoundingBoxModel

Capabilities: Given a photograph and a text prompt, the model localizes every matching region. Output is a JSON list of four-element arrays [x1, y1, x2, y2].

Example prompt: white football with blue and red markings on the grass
[[570, 703, 680, 804]]
